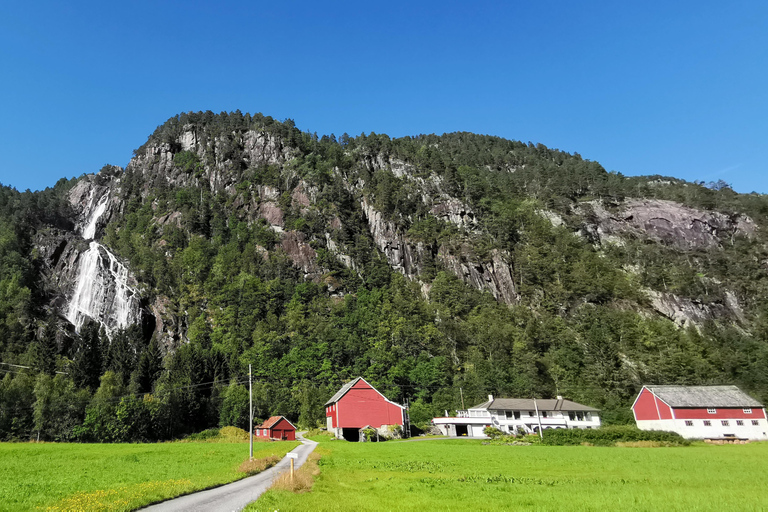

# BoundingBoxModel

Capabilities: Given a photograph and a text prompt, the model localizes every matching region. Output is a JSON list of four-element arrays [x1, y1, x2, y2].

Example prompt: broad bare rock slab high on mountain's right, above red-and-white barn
[[585, 199, 757, 249]]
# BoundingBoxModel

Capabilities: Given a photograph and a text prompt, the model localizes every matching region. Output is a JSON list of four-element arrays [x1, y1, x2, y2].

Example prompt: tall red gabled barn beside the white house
[[325, 377, 407, 441]]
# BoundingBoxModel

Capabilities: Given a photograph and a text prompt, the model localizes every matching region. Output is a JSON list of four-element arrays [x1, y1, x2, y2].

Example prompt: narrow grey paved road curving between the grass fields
[[140, 433, 317, 512]]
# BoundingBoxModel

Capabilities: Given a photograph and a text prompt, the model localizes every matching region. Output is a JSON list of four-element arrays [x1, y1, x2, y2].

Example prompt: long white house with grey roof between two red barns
[[432, 395, 600, 437]]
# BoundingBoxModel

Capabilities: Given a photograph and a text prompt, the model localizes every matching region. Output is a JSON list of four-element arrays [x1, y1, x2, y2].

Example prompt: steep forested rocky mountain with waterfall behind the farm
[[0, 112, 768, 440]]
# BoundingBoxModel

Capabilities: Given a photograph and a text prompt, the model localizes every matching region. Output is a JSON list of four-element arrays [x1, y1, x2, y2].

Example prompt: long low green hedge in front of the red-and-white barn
[[541, 426, 691, 446]]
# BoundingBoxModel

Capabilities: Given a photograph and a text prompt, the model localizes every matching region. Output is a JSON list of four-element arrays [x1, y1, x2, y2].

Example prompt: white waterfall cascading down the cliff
[[66, 185, 139, 337]]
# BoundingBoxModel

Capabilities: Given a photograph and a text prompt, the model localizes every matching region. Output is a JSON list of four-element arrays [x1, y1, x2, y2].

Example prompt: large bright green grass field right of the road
[[252, 440, 768, 512]]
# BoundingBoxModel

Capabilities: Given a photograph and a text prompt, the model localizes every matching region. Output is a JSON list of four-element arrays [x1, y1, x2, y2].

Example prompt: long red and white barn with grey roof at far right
[[632, 386, 768, 440]]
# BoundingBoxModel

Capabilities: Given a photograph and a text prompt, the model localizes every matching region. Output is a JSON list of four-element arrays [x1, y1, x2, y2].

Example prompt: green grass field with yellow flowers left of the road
[[0, 442, 299, 512]]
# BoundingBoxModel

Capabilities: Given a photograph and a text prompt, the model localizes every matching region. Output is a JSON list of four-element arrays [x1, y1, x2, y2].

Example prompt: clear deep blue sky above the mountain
[[0, 0, 768, 193]]
